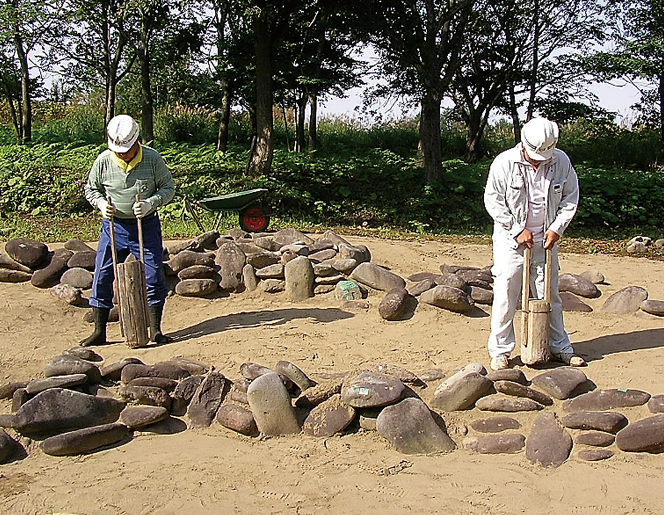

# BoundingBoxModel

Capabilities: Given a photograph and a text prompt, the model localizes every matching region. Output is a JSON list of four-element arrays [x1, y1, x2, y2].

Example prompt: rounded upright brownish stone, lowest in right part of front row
[[526, 411, 572, 467]]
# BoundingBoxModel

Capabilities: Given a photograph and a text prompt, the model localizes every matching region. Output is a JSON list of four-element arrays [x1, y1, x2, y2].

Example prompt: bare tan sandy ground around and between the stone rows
[[0, 238, 664, 515]]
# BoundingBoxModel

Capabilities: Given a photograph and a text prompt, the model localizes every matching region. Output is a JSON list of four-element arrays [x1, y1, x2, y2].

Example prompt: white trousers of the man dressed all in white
[[489, 242, 573, 358]]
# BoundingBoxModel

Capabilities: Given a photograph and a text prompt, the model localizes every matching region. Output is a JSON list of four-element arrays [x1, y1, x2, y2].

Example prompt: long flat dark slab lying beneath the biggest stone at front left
[[40, 424, 131, 456]]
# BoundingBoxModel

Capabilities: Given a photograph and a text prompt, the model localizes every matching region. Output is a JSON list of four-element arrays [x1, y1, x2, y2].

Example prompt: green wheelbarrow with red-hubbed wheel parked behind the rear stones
[[184, 188, 270, 232]]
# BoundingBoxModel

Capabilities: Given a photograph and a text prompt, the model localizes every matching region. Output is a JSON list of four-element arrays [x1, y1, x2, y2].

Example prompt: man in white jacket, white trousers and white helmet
[[484, 118, 585, 370]]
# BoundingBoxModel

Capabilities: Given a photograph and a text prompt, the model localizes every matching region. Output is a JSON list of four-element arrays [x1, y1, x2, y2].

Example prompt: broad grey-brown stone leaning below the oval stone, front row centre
[[376, 397, 455, 454]]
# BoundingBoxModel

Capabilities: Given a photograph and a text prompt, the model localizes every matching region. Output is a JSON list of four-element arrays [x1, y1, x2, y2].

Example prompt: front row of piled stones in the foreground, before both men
[[0, 348, 664, 467]]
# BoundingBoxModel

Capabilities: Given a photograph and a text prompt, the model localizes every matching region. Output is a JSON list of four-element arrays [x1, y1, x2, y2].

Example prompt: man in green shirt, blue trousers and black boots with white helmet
[[80, 114, 175, 347]]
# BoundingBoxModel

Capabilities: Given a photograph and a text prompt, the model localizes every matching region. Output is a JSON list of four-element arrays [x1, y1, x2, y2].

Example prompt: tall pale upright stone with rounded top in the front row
[[247, 373, 300, 436]]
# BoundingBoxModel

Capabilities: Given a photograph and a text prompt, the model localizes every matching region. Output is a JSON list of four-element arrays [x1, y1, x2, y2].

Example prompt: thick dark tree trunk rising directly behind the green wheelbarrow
[[249, 12, 274, 177]]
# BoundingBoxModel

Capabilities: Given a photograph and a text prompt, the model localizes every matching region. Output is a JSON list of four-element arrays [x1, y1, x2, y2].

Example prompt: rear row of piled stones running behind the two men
[[0, 229, 664, 321]]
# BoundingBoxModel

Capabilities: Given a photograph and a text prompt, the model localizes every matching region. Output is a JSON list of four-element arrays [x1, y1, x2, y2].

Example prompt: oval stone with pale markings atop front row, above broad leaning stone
[[341, 371, 404, 408]]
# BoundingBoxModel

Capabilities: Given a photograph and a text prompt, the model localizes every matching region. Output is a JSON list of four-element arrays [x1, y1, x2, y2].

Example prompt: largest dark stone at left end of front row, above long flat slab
[[12, 388, 125, 435]]
